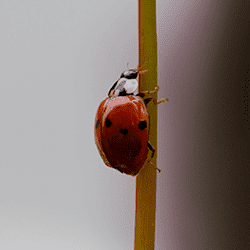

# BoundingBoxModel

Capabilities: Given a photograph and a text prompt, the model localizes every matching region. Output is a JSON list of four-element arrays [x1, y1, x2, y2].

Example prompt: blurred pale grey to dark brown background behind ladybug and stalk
[[0, 0, 250, 250]]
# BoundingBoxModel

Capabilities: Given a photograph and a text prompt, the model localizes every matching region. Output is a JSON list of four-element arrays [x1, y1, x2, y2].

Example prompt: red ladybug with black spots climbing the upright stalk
[[95, 64, 168, 176]]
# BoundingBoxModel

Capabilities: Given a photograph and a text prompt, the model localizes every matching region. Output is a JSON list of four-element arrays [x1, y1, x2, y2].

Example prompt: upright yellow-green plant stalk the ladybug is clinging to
[[134, 0, 157, 250]]
